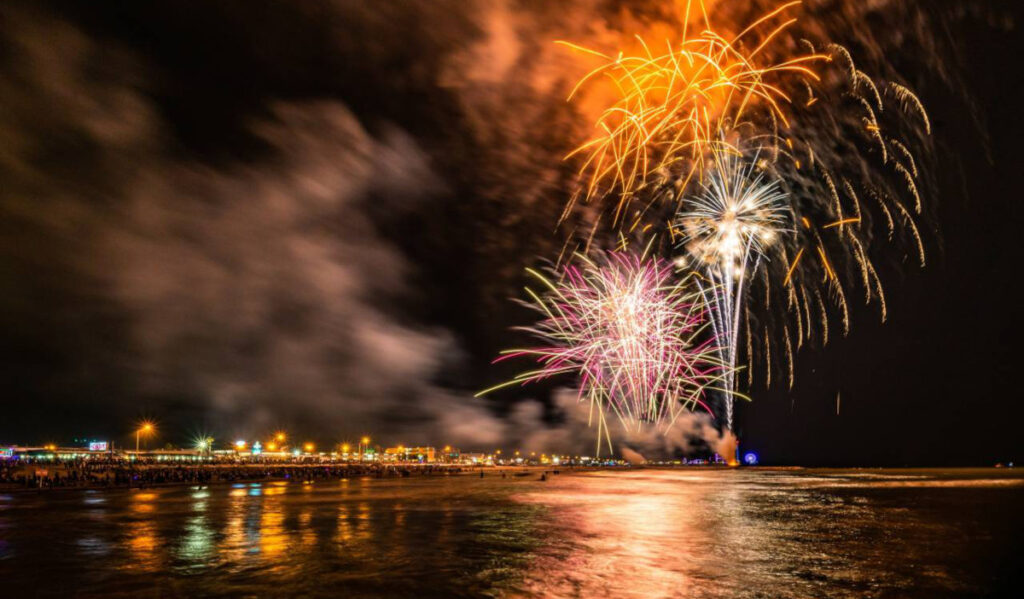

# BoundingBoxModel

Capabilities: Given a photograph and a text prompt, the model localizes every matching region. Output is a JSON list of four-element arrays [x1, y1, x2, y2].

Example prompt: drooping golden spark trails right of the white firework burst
[[746, 40, 931, 393]]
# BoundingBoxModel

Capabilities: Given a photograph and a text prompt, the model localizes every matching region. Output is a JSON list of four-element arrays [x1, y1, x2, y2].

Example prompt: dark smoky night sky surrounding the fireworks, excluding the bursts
[[0, 0, 1024, 465]]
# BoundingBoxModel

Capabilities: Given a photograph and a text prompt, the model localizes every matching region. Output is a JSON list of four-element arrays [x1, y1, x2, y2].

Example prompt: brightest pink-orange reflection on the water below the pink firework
[[520, 472, 716, 598]]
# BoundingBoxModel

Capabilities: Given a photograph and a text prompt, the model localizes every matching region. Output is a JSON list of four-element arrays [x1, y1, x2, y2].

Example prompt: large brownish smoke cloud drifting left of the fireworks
[[0, 1, 589, 446]]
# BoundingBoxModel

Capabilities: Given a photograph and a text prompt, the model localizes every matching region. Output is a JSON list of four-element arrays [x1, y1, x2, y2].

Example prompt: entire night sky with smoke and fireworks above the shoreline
[[0, 0, 1007, 485]]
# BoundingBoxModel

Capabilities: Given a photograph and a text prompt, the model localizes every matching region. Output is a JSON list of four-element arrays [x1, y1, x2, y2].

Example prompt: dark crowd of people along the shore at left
[[0, 458, 462, 489]]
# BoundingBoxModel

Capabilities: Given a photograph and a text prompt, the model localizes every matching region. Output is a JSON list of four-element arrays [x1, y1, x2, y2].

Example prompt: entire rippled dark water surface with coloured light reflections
[[0, 469, 1024, 598]]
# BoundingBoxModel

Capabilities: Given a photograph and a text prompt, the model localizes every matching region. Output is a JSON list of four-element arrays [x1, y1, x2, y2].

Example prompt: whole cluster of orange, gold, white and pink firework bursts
[[483, 0, 931, 448]]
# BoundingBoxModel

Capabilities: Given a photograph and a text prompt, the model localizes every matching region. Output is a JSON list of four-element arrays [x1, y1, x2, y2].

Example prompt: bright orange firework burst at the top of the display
[[558, 0, 827, 224]]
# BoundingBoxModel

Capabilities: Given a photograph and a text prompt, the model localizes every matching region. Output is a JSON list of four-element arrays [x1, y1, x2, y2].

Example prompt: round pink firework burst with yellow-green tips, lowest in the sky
[[477, 252, 728, 448]]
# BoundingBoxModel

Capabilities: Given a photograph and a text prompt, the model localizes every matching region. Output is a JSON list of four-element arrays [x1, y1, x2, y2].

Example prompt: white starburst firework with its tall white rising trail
[[677, 151, 790, 430]]
